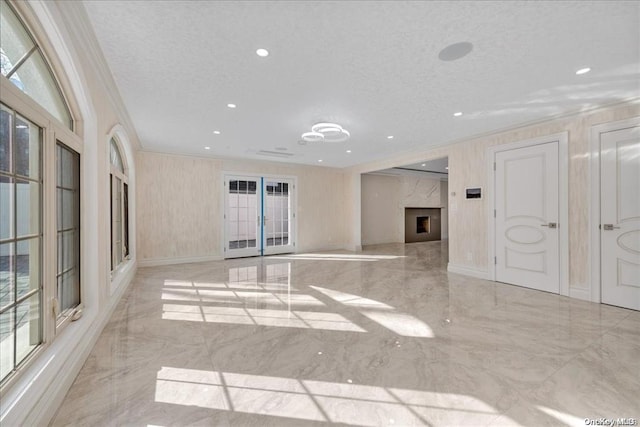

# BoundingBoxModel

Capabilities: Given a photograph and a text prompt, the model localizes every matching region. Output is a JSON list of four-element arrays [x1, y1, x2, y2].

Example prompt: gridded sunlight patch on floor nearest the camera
[[155, 366, 498, 426]]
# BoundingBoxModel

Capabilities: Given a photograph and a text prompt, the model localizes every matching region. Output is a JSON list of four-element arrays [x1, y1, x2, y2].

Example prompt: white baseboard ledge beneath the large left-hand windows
[[0, 265, 136, 426]]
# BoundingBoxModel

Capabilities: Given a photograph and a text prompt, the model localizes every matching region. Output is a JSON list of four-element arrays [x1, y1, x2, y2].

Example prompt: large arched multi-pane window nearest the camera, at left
[[0, 0, 82, 391]]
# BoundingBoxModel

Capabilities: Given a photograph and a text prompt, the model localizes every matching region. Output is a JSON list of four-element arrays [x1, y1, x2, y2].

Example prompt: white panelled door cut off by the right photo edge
[[600, 126, 640, 310]]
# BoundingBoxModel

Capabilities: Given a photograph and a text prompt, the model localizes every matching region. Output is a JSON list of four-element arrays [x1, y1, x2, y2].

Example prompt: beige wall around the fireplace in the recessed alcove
[[362, 174, 444, 245]]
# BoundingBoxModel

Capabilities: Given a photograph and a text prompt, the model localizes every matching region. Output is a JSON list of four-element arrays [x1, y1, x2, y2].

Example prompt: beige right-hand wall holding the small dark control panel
[[349, 101, 640, 289]]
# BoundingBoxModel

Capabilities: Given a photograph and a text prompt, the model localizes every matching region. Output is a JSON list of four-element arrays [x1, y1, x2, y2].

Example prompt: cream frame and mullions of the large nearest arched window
[[0, 2, 81, 394]]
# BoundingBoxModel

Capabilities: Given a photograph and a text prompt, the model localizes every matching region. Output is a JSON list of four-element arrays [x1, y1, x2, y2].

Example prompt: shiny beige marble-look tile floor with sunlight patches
[[53, 242, 640, 426]]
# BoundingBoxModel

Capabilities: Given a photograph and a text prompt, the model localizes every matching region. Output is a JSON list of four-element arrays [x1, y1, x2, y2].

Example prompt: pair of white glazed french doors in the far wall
[[224, 175, 295, 258]]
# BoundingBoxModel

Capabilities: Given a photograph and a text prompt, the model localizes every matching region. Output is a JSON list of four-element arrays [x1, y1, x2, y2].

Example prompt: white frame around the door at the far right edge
[[585, 117, 640, 303]]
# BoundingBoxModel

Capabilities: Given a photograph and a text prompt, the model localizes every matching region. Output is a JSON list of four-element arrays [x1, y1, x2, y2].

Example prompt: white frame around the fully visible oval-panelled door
[[486, 132, 569, 296]]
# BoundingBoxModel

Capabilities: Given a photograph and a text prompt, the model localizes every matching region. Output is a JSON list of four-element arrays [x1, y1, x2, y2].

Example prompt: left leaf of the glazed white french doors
[[225, 176, 261, 258]]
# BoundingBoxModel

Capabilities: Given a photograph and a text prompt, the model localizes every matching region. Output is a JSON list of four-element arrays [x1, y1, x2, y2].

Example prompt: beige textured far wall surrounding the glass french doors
[[137, 151, 349, 263]]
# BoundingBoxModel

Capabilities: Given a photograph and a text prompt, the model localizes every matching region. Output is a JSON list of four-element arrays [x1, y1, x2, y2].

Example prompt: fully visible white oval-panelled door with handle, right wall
[[494, 142, 566, 293]]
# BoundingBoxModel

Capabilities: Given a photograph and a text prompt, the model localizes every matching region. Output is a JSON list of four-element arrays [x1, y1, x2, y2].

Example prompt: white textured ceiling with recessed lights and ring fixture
[[84, 1, 640, 167]]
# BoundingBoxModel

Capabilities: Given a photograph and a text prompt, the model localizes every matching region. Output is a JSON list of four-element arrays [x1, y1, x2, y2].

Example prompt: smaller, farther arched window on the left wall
[[109, 138, 129, 271]]
